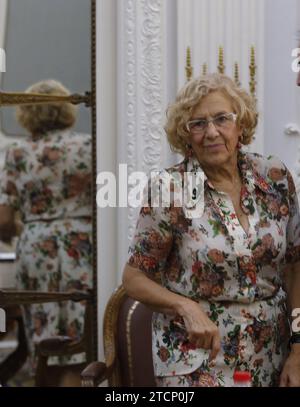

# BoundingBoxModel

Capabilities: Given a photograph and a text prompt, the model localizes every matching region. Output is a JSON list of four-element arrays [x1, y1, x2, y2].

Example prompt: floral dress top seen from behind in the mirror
[[0, 131, 91, 222]]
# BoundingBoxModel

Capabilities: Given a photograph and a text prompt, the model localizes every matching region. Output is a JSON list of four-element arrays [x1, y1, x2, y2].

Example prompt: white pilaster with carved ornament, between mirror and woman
[[117, 0, 176, 278]]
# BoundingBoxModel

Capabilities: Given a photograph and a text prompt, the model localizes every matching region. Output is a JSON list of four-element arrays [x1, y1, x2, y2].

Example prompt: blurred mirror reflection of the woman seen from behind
[[0, 80, 92, 380]]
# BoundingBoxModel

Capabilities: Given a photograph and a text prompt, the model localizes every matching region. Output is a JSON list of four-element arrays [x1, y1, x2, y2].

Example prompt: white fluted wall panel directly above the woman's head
[[177, 0, 265, 153]]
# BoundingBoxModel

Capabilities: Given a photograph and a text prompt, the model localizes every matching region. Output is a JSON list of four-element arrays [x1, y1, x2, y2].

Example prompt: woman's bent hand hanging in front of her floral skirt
[[178, 298, 221, 361]]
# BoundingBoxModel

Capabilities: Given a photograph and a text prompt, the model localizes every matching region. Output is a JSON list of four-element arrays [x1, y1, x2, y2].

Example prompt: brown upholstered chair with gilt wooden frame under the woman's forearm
[[81, 286, 155, 387]]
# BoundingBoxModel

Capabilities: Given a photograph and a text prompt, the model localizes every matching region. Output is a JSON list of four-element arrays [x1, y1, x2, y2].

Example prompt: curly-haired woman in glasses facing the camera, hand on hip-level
[[123, 74, 300, 387]]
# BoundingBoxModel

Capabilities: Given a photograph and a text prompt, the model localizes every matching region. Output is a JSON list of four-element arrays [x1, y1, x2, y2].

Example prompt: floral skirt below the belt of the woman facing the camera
[[153, 291, 289, 387]]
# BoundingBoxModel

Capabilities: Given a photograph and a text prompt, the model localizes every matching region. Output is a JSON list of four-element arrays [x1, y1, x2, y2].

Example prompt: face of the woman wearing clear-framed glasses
[[190, 91, 242, 167]]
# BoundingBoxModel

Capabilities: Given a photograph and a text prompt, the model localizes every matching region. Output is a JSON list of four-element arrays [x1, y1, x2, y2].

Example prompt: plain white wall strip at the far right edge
[[262, 0, 300, 178]]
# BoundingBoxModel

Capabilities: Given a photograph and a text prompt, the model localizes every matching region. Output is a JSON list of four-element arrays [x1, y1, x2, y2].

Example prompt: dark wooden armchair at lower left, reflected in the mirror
[[0, 290, 94, 386]]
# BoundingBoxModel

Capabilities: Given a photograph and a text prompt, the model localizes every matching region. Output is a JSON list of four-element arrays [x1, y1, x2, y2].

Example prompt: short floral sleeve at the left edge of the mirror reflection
[[0, 146, 20, 210]]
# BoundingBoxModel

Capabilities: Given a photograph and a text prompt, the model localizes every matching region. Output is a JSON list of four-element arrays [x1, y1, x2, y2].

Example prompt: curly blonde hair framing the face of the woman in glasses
[[164, 73, 258, 155]]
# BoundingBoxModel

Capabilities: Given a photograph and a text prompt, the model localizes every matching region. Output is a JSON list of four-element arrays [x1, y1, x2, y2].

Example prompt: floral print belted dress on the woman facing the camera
[[128, 150, 300, 387]]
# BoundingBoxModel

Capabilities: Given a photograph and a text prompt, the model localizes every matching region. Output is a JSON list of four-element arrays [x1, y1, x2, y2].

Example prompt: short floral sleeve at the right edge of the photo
[[285, 170, 300, 264]]
